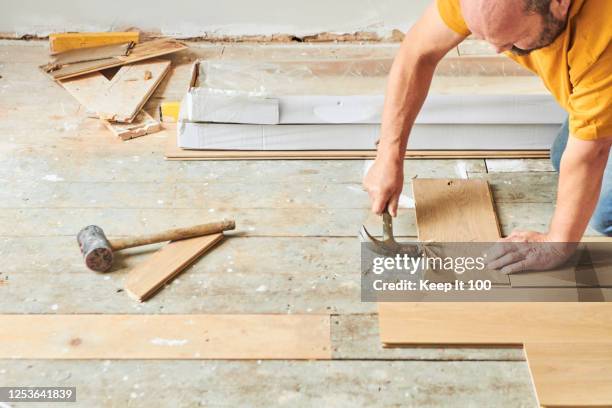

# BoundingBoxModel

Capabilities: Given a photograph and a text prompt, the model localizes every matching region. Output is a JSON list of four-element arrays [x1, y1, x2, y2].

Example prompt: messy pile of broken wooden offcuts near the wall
[[41, 36, 186, 140]]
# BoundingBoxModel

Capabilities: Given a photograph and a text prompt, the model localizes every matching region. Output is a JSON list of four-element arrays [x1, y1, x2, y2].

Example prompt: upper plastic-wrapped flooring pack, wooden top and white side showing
[[181, 58, 565, 125]]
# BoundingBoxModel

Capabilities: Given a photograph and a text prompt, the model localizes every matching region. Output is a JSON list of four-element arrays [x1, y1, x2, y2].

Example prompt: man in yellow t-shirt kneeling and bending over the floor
[[364, 0, 612, 273]]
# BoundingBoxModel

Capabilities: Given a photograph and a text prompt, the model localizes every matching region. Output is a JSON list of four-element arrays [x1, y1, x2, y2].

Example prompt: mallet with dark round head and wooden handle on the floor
[[77, 220, 236, 272]]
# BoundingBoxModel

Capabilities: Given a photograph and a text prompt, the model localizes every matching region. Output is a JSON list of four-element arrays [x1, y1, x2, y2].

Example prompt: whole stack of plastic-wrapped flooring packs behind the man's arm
[[167, 59, 565, 159]]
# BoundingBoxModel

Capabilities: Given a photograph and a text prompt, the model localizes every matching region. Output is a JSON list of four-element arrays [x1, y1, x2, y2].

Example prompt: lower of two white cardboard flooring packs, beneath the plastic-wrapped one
[[177, 122, 559, 151]]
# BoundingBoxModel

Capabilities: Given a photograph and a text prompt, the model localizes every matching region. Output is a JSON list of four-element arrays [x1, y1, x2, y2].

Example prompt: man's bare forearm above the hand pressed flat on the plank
[[549, 137, 610, 242]]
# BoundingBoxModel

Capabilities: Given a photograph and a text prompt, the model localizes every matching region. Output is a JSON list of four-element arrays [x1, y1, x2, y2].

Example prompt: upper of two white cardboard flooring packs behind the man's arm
[[181, 88, 567, 125]]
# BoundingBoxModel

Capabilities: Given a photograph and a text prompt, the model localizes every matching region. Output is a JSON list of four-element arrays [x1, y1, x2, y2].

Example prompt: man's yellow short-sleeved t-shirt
[[436, 0, 612, 140]]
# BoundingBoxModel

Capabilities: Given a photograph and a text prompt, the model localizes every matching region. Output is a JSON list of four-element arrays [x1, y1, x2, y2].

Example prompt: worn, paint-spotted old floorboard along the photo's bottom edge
[[0, 360, 536, 408]]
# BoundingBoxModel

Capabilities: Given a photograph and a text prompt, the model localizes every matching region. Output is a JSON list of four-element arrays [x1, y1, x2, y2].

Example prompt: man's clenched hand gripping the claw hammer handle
[[363, 156, 404, 217]]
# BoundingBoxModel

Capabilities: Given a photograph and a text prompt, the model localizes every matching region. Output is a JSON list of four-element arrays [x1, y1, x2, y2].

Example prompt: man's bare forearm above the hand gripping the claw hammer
[[378, 37, 438, 160]]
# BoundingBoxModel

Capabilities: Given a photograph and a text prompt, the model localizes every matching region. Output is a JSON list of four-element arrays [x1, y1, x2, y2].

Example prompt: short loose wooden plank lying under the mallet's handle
[[125, 234, 223, 302]]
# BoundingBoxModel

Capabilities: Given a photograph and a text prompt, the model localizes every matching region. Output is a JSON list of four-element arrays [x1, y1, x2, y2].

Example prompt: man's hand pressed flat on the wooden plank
[[487, 231, 577, 274]]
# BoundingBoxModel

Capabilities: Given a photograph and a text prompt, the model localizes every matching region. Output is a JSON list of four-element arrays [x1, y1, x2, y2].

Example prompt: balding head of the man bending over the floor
[[461, 0, 571, 55]]
